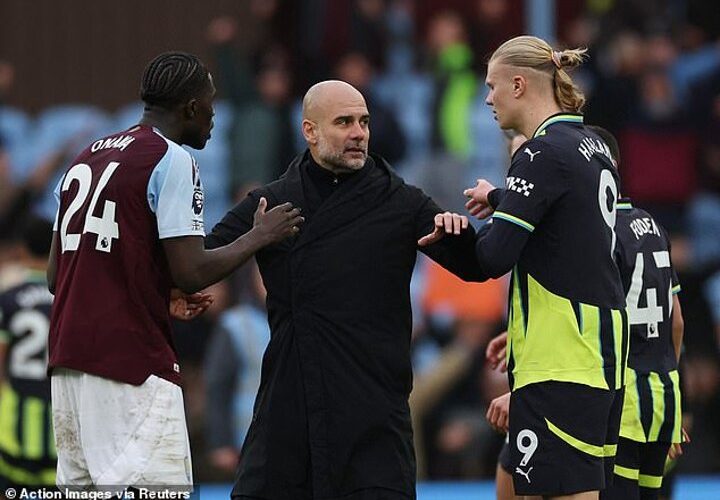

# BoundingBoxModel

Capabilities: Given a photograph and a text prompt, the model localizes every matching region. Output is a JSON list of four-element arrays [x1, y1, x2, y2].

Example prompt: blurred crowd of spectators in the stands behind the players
[[0, 0, 720, 481]]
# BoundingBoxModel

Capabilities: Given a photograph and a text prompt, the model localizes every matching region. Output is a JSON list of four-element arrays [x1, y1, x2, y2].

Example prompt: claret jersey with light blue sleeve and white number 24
[[49, 125, 204, 385]]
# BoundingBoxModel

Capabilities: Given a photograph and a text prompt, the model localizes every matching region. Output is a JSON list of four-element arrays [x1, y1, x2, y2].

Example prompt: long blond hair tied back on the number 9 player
[[490, 35, 587, 113]]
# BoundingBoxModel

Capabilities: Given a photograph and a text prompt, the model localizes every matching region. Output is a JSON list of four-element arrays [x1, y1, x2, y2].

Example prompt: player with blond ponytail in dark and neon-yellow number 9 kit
[[465, 36, 628, 498]]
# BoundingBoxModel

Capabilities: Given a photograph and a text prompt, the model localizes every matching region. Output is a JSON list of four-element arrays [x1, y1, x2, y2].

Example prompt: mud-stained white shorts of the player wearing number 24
[[51, 369, 192, 491]]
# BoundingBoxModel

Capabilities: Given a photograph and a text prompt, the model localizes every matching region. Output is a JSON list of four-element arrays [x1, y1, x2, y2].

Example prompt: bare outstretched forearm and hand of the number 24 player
[[162, 198, 305, 293]]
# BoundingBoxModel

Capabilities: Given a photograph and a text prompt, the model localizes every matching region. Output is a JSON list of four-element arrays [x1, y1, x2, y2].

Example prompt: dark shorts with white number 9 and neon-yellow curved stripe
[[510, 381, 624, 496]]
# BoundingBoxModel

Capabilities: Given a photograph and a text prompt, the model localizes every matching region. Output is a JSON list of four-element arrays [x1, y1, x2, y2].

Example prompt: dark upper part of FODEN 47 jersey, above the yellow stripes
[[616, 199, 680, 373]]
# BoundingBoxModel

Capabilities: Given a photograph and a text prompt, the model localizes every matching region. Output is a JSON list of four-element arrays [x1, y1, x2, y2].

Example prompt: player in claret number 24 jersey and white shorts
[[48, 52, 303, 491]]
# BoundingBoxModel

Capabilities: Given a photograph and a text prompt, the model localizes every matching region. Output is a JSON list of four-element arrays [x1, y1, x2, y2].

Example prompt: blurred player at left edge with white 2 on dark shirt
[[0, 216, 56, 491]]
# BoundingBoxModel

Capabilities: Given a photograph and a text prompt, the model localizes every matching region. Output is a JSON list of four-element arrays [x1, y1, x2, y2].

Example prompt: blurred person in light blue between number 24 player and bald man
[[205, 262, 270, 473]]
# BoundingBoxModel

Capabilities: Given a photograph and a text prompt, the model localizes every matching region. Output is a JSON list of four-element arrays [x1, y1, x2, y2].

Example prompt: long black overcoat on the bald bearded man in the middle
[[206, 152, 482, 500]]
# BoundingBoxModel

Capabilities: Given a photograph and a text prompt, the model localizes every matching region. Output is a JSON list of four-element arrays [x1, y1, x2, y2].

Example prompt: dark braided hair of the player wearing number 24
[[140, 52, 210, 108]]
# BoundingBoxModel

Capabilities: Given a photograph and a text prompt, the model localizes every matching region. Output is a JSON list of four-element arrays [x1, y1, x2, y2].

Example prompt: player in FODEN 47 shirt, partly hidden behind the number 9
[[591, 127, 685, 500]]
